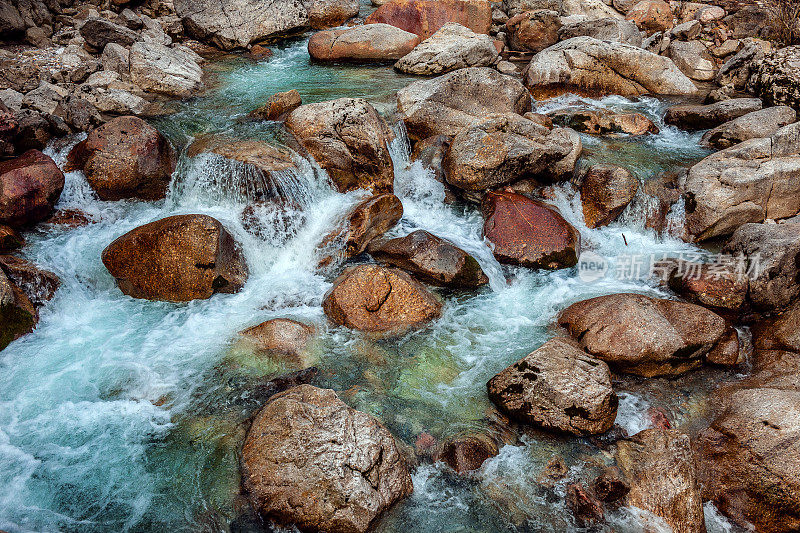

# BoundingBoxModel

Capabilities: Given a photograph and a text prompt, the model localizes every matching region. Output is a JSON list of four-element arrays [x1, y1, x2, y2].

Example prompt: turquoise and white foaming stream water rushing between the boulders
[[0, 39, 744, 533]]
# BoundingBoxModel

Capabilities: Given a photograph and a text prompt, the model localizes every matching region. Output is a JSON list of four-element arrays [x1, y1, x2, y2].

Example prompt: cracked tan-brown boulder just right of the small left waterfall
[[286, 98, 394, 193]]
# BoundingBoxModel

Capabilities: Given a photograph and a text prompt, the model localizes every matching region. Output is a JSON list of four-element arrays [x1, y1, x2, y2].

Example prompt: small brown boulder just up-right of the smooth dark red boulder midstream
[[581, 165, 639, 228]]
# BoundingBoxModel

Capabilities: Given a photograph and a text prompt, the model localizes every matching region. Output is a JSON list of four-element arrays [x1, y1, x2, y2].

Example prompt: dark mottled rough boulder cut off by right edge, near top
[[751, 45, 800, 110]]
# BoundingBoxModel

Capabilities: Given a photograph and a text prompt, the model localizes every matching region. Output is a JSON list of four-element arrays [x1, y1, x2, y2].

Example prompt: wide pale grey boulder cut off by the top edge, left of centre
[[174, 0, 310, 50]]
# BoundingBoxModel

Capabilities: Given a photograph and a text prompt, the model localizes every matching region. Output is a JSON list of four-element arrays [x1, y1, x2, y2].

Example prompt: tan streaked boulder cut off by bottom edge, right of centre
[[615, 428, 706, 533]]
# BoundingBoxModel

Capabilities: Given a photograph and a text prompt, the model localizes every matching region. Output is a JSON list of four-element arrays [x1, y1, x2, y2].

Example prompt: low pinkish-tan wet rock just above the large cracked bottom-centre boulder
[[239, 318, 315, 368]]
